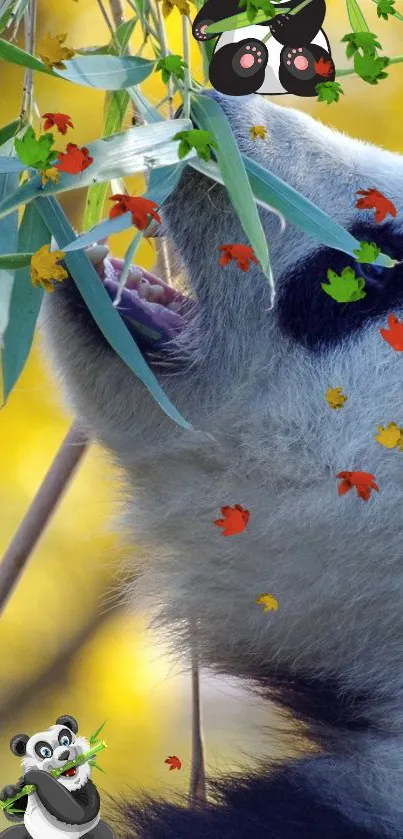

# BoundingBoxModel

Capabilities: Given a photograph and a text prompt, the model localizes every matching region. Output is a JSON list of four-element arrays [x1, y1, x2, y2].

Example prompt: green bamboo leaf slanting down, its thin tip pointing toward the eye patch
[[191, 94, 274, 289]]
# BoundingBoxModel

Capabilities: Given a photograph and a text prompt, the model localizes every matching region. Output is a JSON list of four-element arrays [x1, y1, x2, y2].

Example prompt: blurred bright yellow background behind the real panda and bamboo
[[0, 0, 403, 829]]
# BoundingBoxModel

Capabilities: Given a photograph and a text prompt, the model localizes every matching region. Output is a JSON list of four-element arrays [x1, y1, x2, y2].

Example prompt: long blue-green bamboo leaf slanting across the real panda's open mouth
[[34, 198, 192, 429]]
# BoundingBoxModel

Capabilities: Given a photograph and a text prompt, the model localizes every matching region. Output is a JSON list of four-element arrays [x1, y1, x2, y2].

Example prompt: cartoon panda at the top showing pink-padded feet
[[192, 0, 336, 96]]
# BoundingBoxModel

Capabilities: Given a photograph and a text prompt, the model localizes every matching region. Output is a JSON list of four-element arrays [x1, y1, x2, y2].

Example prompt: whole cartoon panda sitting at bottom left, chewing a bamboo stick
[[0, 715, 114, 839]]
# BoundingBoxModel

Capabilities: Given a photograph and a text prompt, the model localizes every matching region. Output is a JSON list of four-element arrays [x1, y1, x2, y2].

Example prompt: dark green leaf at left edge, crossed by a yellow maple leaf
[[0, 204, 50, 402]]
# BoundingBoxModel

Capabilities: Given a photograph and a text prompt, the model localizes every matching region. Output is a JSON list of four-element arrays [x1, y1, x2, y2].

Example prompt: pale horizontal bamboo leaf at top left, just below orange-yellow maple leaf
[[0, 39, 155, 90]]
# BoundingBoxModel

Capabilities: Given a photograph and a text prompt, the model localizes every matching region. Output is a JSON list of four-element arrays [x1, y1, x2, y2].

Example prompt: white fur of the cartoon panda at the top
[[214, 24, 330, 95]]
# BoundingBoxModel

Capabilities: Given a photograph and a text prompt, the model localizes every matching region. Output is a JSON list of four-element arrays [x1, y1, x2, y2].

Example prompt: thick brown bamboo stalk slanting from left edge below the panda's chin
[[0, 425, 88, 614]]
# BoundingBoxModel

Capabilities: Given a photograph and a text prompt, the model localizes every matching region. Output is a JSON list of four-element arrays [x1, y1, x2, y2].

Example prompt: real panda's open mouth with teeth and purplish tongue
[[87, 245, 195, 350]]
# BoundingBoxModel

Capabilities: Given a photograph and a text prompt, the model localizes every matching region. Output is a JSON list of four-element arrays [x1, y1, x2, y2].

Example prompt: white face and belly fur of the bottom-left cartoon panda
[[21, 725, 100, 839]]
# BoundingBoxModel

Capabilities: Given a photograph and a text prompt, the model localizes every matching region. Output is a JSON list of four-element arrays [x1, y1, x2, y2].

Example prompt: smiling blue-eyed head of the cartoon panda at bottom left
[[11, 717, 91, 791]]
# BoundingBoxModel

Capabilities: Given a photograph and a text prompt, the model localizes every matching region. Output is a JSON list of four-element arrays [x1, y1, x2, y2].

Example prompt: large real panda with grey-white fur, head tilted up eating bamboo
[[38, 92, 403, 839]]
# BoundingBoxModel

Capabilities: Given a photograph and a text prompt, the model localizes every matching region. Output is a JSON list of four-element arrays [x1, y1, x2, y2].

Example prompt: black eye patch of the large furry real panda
[[277, 222, 403, 352]]
